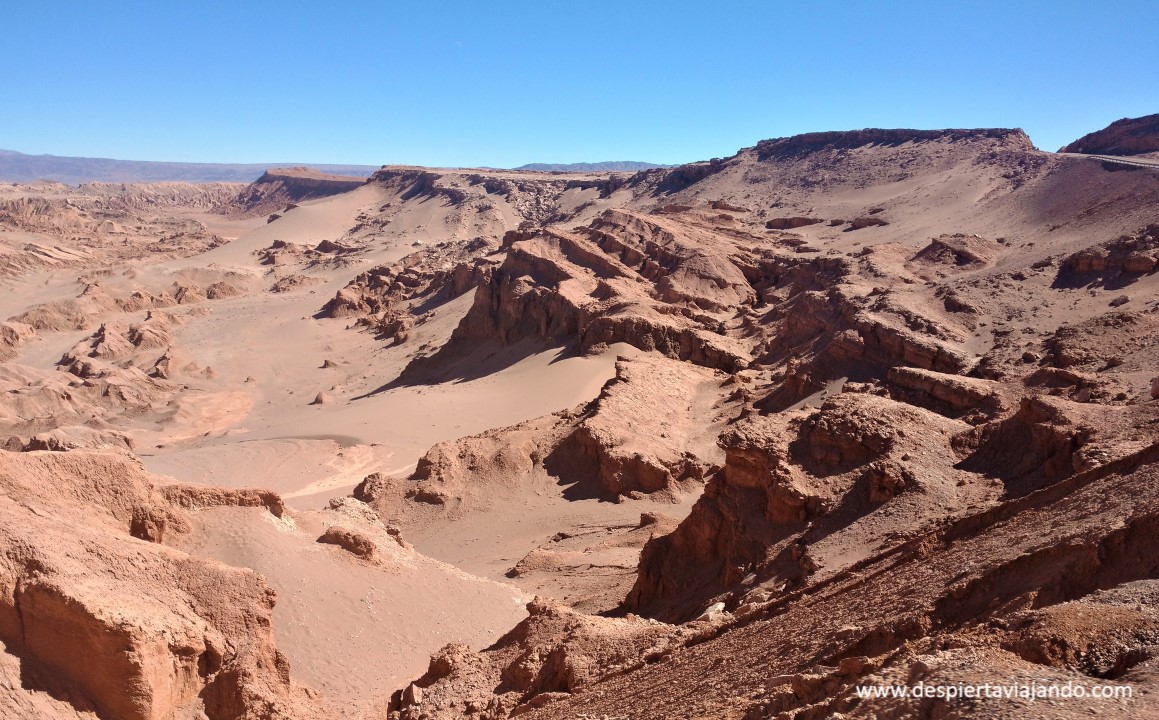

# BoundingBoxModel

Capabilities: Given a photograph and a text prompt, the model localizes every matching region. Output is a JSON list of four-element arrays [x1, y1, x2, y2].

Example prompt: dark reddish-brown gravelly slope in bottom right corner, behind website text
[[493, 438, 1159, 720]]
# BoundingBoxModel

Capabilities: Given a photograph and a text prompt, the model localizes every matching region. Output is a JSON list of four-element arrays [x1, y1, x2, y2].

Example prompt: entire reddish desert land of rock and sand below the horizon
[[0, 116, 1159, 720]]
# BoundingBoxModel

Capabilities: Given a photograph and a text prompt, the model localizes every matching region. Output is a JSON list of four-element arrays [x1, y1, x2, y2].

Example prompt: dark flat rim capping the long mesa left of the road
[[756, 128, 1035, 160]]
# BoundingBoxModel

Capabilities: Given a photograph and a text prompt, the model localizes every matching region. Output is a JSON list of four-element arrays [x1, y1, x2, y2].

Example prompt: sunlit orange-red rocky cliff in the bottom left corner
[[0, 452, 326, 720]]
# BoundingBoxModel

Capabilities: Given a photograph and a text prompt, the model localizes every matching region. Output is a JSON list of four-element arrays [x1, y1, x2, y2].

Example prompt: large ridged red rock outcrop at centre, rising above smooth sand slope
[[412, 212, 753, 370]]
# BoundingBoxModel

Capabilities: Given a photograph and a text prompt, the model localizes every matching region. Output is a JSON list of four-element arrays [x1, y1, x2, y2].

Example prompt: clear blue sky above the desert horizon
[[0, 0, 1159, 167]]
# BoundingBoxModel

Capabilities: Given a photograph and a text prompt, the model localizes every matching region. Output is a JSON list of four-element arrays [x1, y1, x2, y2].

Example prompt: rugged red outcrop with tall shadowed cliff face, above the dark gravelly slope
[[625, 393, 969, 619]]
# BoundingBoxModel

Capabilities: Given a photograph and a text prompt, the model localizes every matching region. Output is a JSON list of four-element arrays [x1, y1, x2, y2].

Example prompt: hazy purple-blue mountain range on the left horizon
[[0, 150, 379, 186]]
